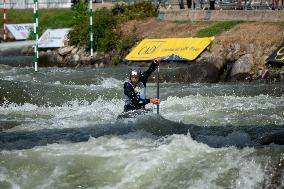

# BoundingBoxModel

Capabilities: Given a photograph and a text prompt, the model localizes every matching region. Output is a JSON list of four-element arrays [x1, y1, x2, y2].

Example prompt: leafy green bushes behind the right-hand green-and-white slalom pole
[[69, 1, 157, 64]]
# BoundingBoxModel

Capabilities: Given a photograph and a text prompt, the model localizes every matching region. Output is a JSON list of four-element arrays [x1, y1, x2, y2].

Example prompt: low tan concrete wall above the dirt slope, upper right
[[159, 9, 284, 22]]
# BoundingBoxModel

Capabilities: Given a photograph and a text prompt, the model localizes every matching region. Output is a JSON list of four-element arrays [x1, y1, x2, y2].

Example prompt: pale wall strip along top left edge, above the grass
[[0, 0, 71, 9]]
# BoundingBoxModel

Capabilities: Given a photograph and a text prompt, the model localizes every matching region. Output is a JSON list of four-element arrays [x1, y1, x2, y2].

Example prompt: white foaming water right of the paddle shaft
[[160, 95, 284, 126]]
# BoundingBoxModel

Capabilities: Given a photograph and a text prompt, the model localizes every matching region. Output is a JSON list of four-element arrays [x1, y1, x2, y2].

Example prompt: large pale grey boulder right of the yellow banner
[[230, 54, 253, 78]]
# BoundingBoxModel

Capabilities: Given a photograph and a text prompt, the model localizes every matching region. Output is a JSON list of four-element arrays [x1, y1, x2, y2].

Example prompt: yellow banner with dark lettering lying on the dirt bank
[[125, 37, 214, 61]]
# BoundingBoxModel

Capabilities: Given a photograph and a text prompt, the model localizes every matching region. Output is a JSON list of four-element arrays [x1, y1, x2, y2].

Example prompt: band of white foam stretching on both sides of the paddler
[[0, 91, 284, 129]]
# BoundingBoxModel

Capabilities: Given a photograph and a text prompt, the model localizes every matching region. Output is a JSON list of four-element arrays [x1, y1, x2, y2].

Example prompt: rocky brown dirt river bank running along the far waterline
[[0, 18, 284, 83]]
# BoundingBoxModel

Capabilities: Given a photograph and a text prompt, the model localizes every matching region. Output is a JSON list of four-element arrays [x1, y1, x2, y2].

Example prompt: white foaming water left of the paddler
[[0, 98, 124, 131]]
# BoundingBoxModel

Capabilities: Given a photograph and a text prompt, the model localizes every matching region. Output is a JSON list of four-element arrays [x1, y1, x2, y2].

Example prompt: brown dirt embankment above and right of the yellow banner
[[121, 18, 284, 82]]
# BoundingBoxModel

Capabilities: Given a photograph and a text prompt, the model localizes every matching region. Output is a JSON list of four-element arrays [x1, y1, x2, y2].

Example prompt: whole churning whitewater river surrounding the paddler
[[0, 65, 284, 189]]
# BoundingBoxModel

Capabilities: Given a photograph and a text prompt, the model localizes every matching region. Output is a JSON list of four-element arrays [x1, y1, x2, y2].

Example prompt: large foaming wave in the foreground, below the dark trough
[[0, 132, 264, 189]]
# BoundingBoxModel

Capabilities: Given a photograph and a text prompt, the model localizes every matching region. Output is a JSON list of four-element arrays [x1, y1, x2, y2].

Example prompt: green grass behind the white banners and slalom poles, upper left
[[0, 9, 73, 30]]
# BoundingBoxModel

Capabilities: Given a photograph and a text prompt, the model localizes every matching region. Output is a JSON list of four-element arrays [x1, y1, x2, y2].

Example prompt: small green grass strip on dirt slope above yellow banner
[[195, 21, 242, 37]]
